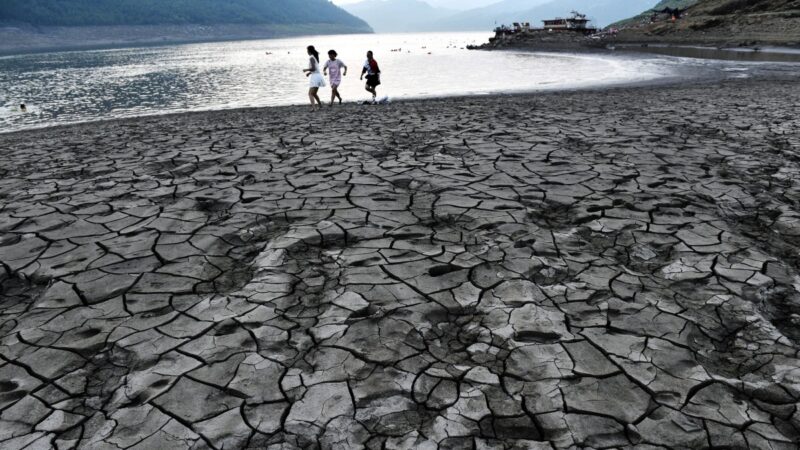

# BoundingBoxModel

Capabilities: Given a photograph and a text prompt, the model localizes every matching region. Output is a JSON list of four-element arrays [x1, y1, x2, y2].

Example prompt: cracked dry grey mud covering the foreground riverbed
[[0, 80, 800, 449]]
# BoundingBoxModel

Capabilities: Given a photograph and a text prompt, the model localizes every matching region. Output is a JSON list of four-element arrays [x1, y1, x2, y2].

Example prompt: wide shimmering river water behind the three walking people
[[0, 33, 788, 132]]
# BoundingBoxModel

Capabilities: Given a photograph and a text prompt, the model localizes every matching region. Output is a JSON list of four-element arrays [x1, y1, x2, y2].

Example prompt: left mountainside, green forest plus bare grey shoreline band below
[[0, 0, 372, 55]]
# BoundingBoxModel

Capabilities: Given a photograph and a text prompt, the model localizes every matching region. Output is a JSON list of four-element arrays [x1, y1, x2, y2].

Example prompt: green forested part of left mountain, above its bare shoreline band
[[0, 0, 369, 31]]
